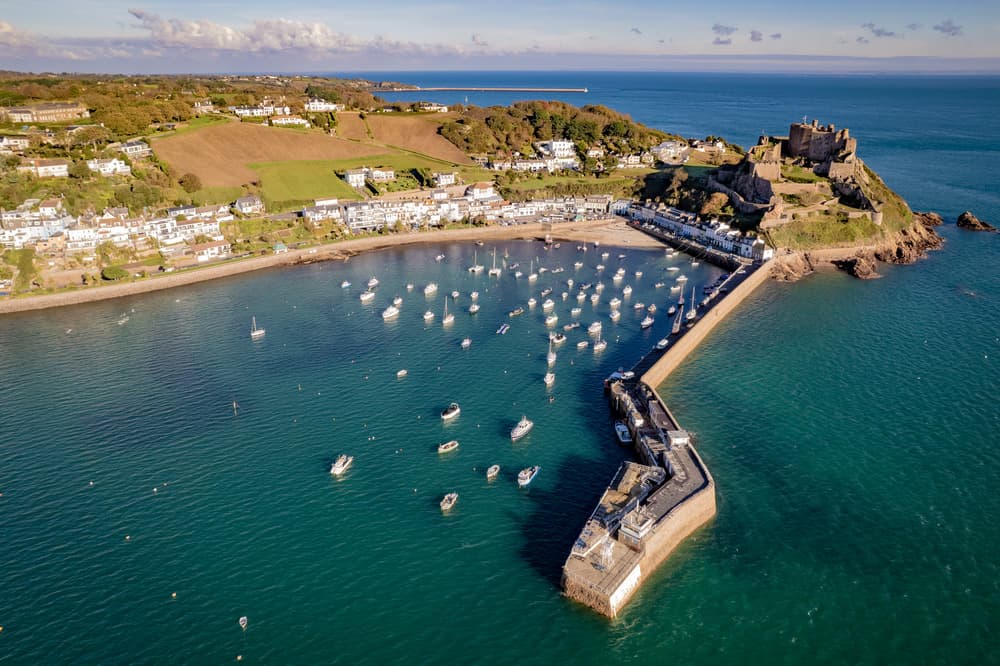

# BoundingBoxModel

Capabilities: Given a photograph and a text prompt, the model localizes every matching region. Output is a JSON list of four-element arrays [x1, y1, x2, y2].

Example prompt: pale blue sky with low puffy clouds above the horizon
[[0, 0, 1000, 74]]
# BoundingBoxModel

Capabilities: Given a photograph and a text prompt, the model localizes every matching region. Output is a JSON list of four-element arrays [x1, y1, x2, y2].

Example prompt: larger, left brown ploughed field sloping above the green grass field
[[152, 122, 385, 187]]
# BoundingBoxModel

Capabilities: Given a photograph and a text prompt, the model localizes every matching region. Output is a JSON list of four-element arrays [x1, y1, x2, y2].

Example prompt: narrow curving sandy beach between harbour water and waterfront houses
[[0, 218, 663, 314]]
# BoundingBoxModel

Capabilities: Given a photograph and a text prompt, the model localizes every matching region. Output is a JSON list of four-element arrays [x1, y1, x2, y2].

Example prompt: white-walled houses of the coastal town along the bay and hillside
[[0, 77, 760, 293]]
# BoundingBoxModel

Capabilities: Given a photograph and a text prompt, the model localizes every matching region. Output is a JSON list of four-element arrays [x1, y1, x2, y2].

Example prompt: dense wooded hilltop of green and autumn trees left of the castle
[[441, 102, 669, 155]]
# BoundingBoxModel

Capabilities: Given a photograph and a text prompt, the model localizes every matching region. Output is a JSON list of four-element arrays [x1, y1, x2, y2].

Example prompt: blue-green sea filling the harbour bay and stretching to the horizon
[[0, 72, 1000, 665]]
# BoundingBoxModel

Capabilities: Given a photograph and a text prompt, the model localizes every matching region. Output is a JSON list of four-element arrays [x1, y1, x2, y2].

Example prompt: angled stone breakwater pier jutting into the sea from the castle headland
[[562, 250, 771, 618]]
